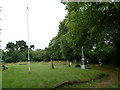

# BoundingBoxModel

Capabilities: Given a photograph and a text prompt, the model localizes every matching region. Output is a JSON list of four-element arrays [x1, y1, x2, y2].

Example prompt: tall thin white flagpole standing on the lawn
[[27, 7, 30, 74]]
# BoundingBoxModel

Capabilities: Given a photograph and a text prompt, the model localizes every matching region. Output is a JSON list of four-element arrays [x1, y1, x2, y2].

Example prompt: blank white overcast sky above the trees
[[0, 0, 67, 49]]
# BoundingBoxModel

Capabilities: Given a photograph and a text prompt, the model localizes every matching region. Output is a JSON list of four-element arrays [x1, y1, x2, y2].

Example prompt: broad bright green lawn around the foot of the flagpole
[[2, 63, 104, 88]]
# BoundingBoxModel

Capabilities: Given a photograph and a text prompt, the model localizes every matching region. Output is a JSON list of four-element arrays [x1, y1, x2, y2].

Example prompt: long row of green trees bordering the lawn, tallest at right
[[4, 2, 120, 65]]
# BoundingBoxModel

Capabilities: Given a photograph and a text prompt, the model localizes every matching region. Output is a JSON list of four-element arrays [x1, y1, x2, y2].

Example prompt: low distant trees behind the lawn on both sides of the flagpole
[[2, 40, 56, 63]]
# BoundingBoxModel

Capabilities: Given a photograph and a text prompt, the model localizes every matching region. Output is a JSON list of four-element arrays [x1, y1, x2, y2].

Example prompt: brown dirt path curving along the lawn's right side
[[95, 65, 118, 88]]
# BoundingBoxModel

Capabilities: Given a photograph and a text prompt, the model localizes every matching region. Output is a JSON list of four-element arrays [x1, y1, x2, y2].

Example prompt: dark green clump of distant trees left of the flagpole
[[3, 40, 34, 62]]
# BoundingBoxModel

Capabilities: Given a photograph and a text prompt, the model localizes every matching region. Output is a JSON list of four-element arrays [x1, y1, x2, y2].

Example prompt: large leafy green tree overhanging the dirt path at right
[[62, 2, 120, 64]]
